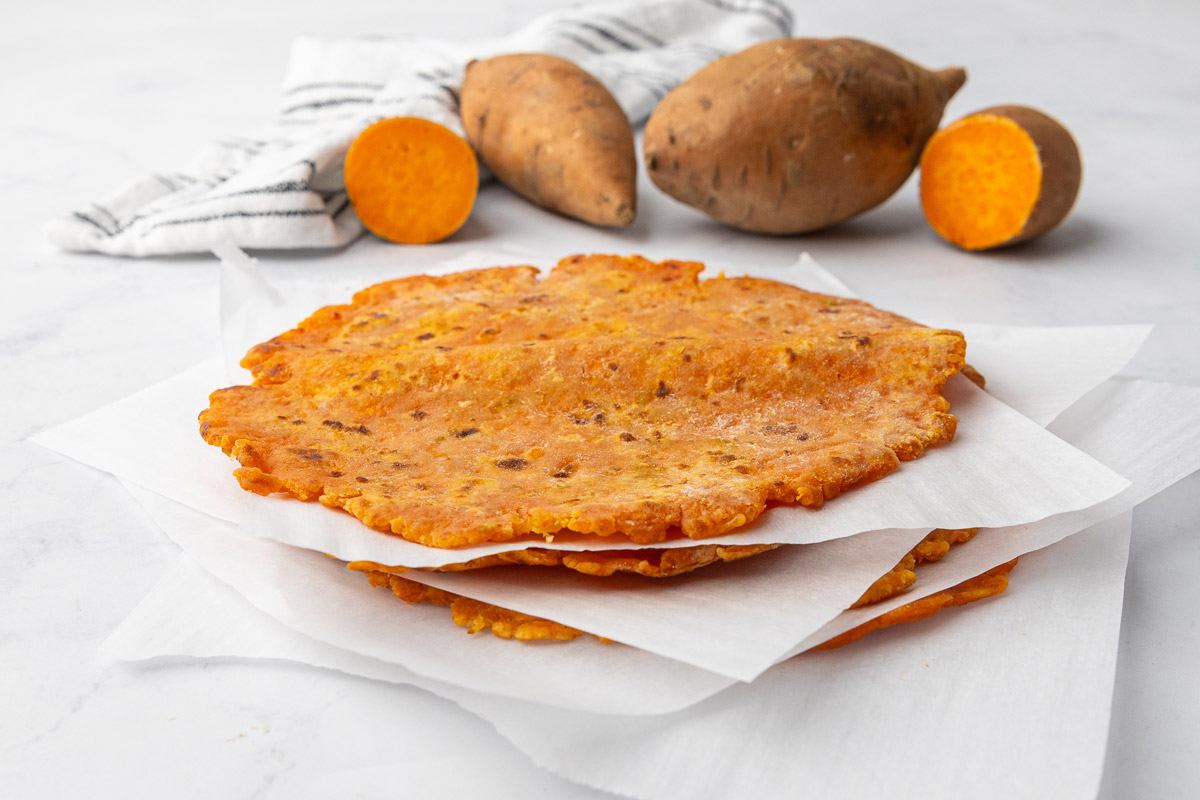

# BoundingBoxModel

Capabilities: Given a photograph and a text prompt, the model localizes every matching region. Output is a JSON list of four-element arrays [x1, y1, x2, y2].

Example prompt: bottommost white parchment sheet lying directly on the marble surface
[[107, 515, 1129, 800]]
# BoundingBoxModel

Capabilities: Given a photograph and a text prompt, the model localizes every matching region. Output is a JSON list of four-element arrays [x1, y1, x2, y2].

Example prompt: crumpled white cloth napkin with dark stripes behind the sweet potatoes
[[47, 0, 792, 255]]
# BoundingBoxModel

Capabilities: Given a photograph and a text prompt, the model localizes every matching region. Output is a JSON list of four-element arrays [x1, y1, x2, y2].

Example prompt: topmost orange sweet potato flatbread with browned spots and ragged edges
[[200, 257, 965, 547]]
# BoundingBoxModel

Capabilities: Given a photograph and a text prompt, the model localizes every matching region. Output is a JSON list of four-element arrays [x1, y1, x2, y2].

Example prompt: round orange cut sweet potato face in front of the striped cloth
[[344, 116, 479, 245]]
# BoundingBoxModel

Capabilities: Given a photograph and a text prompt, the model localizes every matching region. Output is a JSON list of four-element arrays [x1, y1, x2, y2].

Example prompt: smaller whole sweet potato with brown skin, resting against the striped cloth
[[461, 53, 637, 227]]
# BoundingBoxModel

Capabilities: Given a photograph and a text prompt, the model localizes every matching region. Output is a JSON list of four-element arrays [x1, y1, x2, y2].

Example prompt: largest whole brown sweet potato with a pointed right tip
[[643, 38, 966, 234]]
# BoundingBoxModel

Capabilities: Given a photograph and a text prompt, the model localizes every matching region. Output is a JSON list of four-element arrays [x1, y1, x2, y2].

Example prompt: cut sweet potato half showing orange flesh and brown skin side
[[920, 106, 1082, 251]]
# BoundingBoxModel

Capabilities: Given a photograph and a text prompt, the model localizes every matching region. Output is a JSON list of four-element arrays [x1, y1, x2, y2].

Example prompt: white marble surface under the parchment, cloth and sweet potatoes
[[0, 0, 1200, 798]]
